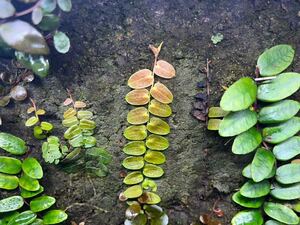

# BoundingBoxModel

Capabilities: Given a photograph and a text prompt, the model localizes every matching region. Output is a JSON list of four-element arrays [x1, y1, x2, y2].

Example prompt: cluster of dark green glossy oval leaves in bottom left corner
[[0, 133, 68, 225]]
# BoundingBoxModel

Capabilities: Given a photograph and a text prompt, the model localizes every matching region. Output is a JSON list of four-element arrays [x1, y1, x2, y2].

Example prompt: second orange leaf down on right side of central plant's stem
[[150, 82, 173, 104]]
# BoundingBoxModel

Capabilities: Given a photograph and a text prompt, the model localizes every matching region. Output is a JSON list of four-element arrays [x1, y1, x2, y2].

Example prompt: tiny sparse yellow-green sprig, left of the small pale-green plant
[[25, 99, 53, 140]]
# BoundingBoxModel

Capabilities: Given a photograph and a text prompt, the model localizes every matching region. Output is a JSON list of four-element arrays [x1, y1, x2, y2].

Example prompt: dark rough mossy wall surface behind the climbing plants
[[0, 0, 300, 225]]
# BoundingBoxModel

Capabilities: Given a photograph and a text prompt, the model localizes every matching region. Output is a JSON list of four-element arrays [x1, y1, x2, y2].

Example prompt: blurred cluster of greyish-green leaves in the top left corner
[[0, 0, 72, 77]]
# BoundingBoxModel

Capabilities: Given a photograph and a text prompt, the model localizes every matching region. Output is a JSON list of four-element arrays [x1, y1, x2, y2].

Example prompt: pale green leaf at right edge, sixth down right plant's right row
[[276, 163, 300, 184]]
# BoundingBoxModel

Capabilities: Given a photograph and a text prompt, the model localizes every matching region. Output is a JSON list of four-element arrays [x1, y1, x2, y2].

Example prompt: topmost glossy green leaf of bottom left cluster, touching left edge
[[0, 132, 27, 155]]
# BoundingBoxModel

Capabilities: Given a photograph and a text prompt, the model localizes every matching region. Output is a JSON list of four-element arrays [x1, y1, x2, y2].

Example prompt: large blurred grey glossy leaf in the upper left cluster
[[0, 20, 49, 55]]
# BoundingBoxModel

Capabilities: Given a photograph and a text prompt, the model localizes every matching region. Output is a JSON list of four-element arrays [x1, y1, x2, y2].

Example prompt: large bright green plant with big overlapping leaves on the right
[[208, 45, 300, 225]]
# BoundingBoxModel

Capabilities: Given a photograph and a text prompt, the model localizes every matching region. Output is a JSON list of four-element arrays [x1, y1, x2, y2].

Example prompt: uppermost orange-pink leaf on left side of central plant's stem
[[128, 69, 154, 89]]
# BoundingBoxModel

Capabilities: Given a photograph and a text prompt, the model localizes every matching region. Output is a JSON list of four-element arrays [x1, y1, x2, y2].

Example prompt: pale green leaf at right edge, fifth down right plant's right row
[[273, 136, 300, 161]]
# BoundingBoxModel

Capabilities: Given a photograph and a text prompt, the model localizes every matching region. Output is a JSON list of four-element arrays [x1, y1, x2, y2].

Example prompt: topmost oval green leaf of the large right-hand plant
[[257, 45, 295, 77]]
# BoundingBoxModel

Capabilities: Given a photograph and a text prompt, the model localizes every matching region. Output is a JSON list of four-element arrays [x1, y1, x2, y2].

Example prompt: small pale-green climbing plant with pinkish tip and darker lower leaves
[[42, 97, 112, 177]]
